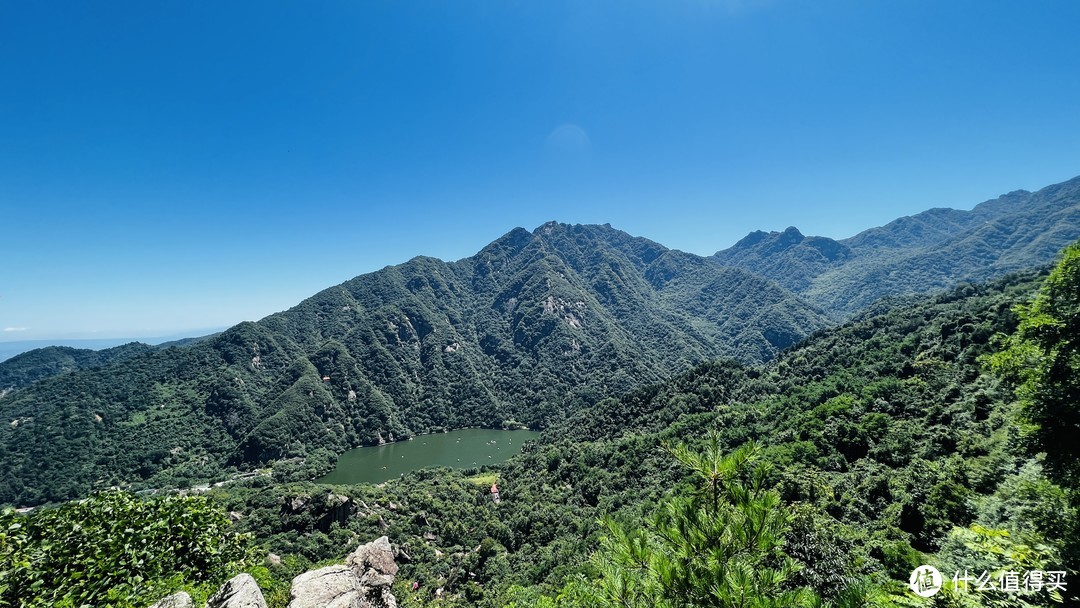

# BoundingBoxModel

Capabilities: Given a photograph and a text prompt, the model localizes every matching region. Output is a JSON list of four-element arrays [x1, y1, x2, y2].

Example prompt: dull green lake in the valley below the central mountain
[[315, 429, 540, 484]]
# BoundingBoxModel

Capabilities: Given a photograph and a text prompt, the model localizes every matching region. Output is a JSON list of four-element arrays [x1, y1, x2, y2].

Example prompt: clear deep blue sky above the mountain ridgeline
[[0, 0, 1080, 340]]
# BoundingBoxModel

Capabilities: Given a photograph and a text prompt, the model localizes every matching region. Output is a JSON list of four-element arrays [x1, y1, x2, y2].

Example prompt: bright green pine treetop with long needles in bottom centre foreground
[[594, 435, 810, 608]]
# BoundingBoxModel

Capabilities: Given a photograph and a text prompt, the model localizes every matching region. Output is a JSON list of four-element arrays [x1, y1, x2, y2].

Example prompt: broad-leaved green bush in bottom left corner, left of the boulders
[[0, 491, 249, 608]]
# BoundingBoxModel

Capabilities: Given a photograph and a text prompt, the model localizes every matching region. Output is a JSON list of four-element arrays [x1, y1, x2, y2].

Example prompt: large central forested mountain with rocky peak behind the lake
[[0, 222, 827, 504]]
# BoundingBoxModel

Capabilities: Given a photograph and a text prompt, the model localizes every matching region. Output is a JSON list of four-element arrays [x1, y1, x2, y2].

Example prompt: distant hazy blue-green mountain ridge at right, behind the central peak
[[713, 177, 1080, 320]]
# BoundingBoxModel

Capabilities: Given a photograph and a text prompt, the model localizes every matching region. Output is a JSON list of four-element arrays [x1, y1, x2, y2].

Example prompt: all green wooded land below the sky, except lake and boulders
[[0, 178, 1080, 608]]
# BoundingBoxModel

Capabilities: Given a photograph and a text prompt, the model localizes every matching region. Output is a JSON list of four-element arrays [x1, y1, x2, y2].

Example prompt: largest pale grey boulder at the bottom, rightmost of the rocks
[[288, 537, 397, 608]]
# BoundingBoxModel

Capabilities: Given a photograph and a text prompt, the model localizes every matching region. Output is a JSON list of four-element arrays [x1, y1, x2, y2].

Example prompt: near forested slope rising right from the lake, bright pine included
[[6, 240, 1080, 607]]
